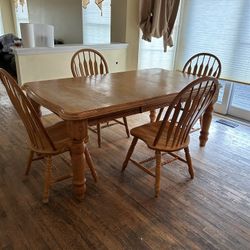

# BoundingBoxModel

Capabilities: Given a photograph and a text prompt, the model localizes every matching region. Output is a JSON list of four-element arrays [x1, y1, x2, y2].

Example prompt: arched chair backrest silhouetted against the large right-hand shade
[[182, 53, 221, 78]]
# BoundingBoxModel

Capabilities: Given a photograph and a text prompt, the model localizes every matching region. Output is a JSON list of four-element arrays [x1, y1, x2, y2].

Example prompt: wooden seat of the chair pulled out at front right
[[130, 121, 189, 152]]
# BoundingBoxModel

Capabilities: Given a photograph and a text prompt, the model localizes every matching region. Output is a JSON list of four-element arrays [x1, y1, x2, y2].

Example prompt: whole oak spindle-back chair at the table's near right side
[[122, 77, 218, 197]]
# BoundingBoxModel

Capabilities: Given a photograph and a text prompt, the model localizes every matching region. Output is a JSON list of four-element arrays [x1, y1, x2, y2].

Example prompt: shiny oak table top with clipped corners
[[23, 69, 197, 120]]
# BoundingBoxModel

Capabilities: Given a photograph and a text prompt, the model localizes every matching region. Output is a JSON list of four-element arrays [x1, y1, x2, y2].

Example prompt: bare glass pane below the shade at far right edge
[[231, 83, 250, 111]]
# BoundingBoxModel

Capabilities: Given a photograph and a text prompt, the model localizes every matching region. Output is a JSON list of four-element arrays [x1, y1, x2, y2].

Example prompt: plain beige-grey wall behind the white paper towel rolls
[[27, 0, 82, 44]]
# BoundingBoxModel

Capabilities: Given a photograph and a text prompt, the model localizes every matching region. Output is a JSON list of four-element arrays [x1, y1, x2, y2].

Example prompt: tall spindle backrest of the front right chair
[[154, 76, 219, 147]]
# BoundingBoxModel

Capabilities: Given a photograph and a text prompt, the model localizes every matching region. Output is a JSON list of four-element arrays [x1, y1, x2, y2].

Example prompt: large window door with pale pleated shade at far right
[[175, 0, 250, 120]]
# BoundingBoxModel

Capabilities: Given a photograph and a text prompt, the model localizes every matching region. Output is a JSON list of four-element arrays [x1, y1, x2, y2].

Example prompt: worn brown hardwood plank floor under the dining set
[[0, 87, 250, 249]]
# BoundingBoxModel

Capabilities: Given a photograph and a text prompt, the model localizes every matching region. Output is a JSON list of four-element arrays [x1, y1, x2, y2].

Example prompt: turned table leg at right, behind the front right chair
[[200, 103, 214, 147]]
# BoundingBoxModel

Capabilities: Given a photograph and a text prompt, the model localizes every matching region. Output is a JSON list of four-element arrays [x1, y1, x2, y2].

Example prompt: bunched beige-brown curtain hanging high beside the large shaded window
[[139, 0, 180, 52]]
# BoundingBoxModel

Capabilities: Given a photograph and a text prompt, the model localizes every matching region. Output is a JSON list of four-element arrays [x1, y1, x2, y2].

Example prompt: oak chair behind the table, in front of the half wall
[[71, 48, 130, 147]]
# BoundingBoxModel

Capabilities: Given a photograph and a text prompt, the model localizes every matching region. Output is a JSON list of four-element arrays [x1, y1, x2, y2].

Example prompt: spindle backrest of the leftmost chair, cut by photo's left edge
[[0, 68, 56, 153]]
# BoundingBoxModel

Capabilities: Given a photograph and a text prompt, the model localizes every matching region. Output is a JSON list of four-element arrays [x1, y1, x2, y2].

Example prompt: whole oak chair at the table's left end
[[0, 69, 97, 203]]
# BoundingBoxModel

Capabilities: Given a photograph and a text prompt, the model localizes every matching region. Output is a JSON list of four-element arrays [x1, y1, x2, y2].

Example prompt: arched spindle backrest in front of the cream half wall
[[71, 49, 108, 77]]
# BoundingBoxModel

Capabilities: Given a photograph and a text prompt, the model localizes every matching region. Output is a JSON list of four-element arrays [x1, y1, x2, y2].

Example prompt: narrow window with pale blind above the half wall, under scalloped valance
[[83, 0, 111, 44]]
